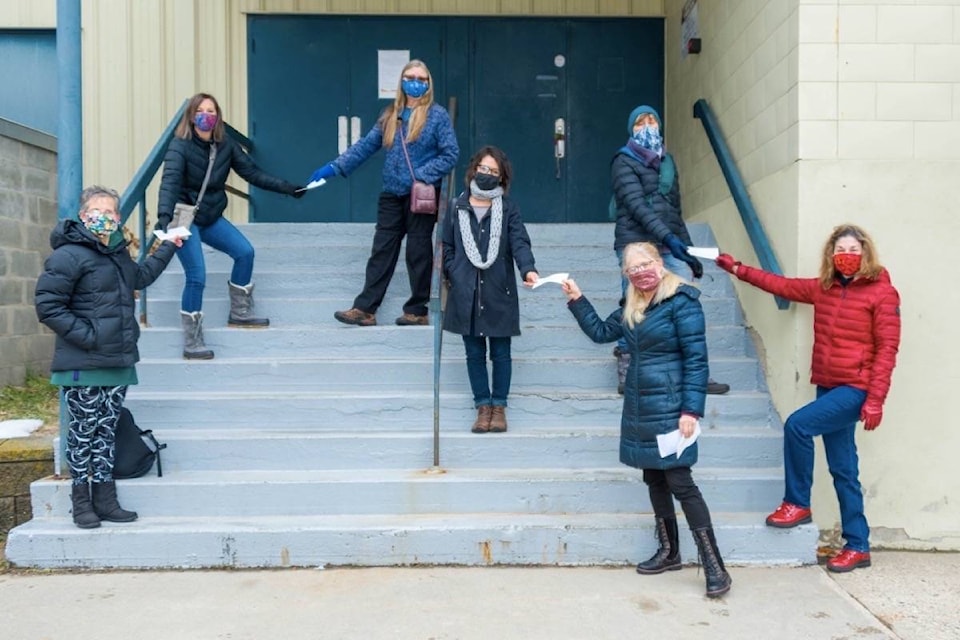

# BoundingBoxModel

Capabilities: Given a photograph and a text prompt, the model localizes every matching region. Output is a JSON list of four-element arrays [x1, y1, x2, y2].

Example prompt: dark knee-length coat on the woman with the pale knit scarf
[[441, 194, 537, 338]]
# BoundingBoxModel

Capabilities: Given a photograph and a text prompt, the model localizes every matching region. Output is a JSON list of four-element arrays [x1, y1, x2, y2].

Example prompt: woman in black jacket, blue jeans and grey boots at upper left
[[157, 93, 303, 360]]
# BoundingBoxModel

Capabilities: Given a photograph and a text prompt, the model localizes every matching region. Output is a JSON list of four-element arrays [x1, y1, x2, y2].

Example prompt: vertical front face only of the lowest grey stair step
[[6, 517, 817, 568]]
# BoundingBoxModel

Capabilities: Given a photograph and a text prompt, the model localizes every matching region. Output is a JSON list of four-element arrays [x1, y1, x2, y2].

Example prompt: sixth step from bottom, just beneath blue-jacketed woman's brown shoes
[[138, 317, 752, 362]]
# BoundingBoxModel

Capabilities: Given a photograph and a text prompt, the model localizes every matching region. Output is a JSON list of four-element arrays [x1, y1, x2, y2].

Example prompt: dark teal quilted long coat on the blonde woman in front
[[568, 285, 709, 469]]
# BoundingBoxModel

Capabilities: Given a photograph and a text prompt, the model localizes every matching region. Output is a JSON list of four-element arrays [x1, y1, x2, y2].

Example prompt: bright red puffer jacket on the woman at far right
[[737, 265, 900, 403]]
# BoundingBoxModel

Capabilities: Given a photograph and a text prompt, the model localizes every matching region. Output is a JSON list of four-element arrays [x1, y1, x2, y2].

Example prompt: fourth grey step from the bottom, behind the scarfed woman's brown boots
[[124, 388, 781, 434]]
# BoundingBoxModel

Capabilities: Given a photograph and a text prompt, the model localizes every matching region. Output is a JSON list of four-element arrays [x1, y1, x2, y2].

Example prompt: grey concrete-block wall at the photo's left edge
[[0, 121, 57, 386]]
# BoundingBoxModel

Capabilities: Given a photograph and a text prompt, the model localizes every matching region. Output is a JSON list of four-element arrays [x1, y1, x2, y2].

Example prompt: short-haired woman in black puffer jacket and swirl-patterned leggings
[[35, 186, 179, 529]]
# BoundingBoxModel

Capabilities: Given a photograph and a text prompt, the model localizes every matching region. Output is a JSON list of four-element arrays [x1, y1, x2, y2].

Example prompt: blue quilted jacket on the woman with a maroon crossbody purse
[[334, 104, 460, 196]]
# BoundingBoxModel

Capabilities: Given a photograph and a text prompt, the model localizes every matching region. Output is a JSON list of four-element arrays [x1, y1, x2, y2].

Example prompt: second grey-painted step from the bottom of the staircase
[[30, 468, 783, 518]]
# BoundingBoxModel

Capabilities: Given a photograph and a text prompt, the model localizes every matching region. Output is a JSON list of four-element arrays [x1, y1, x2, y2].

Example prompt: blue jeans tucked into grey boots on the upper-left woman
[[177, 218, 253, 313]]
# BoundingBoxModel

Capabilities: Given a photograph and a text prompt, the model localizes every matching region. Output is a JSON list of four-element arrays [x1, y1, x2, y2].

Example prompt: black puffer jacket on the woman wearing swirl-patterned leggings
[[35, 220, 176, 371]]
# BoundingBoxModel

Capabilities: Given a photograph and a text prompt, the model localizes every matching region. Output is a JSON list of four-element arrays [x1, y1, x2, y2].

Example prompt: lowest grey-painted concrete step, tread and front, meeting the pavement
[[6, 510, 818, 571]]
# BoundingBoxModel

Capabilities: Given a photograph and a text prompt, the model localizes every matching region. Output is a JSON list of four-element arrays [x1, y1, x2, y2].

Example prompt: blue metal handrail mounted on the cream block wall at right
[[693, 98, 790, 311]]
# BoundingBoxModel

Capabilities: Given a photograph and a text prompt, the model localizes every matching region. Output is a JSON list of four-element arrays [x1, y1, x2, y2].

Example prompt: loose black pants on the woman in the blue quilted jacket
[[353, 192, 437, 316]]
